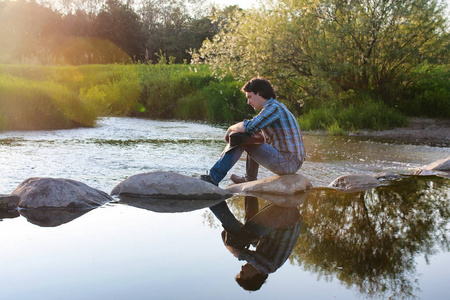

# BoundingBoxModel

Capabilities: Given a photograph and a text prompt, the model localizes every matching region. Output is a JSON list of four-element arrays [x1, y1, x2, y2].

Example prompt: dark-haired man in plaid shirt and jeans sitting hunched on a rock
[[201, 78, 305, 185]]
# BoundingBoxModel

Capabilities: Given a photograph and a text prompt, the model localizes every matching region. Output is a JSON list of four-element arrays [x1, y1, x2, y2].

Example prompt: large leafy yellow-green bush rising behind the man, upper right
[[194, 0, 449, 113]]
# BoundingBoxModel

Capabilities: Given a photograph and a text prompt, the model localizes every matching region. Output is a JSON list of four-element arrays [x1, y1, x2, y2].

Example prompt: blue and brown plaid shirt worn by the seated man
[[244, 98, 306, 162]]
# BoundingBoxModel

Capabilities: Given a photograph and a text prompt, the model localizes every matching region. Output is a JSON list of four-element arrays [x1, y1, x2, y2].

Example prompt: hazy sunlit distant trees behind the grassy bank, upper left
[[0, 0, 231, 65]]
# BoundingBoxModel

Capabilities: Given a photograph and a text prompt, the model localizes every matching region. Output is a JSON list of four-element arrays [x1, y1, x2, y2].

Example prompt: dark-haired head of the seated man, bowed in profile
[[241, 78, 277, 110]]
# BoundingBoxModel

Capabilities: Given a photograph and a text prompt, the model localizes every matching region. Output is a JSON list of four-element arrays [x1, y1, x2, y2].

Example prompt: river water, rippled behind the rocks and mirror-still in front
[[0, 118, 450, 299]]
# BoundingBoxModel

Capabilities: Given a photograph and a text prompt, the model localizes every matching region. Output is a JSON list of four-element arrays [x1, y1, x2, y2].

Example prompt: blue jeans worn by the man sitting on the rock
[[209, 143, 302, 183]]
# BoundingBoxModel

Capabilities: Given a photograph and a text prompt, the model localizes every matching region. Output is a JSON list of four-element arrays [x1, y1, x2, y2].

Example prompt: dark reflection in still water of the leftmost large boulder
[[19, 209, 92, 227]]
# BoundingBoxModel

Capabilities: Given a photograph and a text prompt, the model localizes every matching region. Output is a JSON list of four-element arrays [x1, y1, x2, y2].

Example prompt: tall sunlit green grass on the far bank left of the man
[[0, 64, 248, 130]]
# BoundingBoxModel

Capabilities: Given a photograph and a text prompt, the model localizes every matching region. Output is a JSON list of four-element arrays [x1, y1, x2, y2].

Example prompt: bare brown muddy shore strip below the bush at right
[[304, 118, 450, 147]]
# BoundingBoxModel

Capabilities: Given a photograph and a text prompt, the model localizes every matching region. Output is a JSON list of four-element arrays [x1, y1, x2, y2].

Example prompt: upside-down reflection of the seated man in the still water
[[211, 197, 302, 291]]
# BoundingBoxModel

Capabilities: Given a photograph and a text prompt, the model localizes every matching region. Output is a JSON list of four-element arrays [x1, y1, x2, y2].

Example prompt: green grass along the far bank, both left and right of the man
[[0, 64, 444, 135]]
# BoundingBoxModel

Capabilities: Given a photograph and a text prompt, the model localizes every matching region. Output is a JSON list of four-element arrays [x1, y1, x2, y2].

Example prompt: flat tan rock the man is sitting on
[[225, 174, 312, 195]]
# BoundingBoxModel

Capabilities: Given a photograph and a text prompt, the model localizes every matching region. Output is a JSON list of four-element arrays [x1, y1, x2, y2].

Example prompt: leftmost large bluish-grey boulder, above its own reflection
[[13, 177, 114, 209]]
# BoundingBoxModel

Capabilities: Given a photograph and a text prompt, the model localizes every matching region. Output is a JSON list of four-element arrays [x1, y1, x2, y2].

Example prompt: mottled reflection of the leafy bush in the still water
[[293, 177, 450, 298]]
